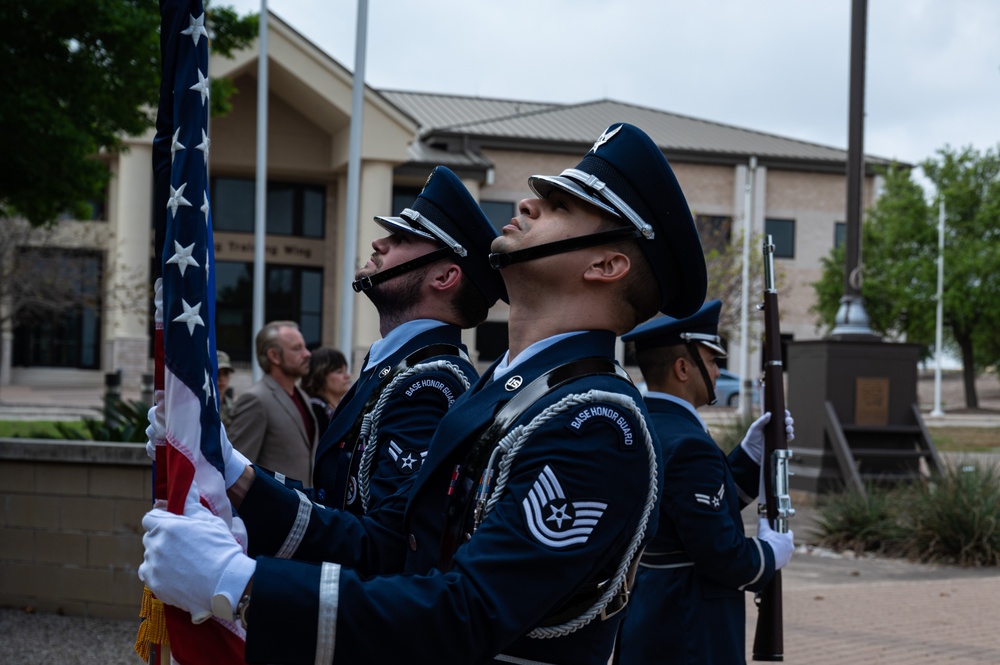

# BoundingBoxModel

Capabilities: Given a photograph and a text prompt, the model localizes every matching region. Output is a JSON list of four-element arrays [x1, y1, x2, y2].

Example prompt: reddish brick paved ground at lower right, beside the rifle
[[743, 503, 1000, 665]]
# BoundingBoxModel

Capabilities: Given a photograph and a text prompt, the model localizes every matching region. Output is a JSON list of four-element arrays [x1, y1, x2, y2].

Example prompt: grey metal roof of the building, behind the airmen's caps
[[380, 90, 890, 169]]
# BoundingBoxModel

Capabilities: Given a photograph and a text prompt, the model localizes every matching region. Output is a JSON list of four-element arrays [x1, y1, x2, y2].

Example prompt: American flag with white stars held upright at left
[[153, 0, 245, 664]]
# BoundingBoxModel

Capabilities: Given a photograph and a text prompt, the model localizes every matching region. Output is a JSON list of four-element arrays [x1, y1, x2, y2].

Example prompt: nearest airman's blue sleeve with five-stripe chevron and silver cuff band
[[247, 392, 660, 663]]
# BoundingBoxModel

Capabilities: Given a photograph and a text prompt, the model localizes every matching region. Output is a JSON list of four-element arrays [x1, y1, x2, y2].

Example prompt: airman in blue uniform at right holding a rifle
[[617, 300, 794, 665]]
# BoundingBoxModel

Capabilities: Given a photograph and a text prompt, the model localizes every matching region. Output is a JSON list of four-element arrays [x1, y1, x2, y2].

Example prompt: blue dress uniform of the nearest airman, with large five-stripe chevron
[[244, 331, 662, 665]]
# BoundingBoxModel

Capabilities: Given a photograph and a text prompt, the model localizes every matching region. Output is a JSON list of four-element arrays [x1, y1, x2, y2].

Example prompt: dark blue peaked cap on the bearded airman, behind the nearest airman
[[375, 166, 507, 307]]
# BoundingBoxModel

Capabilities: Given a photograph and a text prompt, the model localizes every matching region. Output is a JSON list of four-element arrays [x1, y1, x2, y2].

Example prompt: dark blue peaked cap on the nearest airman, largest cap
[[528, 123, 708, 316]]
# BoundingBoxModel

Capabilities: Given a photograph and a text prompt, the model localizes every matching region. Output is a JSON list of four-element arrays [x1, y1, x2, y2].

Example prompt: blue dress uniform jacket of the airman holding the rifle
[[618, 393, 774, 665]]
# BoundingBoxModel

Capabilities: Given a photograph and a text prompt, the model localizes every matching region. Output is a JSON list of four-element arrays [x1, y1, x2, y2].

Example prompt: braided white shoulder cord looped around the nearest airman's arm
[[480, 390, 657, 639]]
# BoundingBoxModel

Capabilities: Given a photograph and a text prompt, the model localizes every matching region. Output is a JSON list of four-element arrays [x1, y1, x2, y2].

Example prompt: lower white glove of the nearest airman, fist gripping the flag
[[139, 508, 257, 623]]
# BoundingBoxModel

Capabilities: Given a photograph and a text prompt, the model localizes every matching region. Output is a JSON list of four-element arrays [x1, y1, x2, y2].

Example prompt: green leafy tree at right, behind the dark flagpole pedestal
[[814, 147, 1000, 409]]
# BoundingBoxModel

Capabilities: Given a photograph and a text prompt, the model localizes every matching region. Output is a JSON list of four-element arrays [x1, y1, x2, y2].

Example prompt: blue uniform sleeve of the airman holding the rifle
[[663, 438, 774, 590]]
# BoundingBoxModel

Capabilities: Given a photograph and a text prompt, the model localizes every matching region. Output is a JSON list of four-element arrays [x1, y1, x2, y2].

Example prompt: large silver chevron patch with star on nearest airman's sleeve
[[521, 466, 608, 549]]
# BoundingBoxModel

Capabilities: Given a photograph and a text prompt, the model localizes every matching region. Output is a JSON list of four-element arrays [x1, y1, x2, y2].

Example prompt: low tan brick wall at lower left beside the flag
[[0, 439, 152, 624]]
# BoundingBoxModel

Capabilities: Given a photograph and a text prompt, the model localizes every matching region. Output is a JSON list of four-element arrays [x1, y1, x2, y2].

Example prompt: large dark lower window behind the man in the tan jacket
[[215, 261, 323, 362]]
